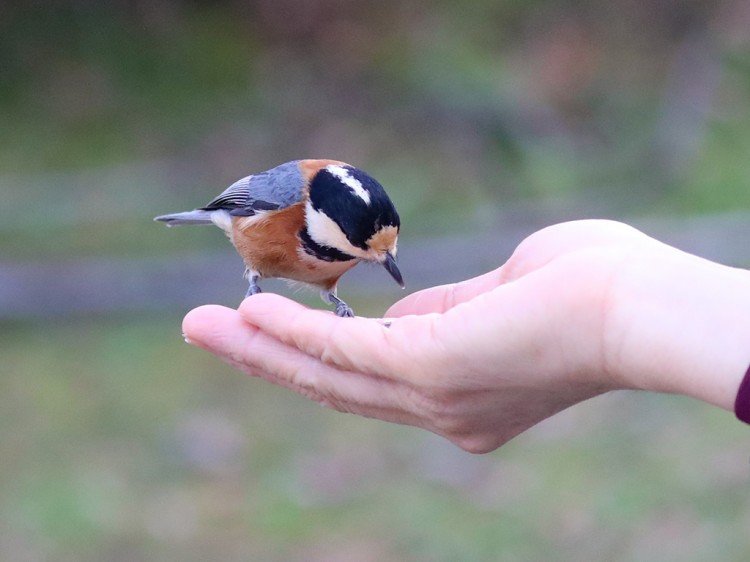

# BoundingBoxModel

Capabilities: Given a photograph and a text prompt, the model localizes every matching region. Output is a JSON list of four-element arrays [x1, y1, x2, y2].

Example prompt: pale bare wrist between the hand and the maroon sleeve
[[610, 247, 750, 411]]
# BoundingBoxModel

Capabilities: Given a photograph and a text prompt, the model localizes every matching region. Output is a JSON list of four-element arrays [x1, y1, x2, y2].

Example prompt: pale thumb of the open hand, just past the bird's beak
[[385, 268, 501, 318]]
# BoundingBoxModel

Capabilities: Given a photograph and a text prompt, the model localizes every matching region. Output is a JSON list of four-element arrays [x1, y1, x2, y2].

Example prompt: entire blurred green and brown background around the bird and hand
[[0, 0, 750, 561]]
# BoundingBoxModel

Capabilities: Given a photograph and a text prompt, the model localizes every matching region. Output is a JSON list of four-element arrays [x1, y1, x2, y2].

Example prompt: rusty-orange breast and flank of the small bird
[[232, 203, 357, 290]]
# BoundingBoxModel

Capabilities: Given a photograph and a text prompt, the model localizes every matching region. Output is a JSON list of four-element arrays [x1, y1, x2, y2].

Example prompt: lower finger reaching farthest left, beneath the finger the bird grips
[[183, 306, 428, 425]]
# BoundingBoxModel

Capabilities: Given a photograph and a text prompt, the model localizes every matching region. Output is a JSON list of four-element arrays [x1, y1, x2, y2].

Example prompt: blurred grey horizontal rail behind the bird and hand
[[0, 213, 750, 320]]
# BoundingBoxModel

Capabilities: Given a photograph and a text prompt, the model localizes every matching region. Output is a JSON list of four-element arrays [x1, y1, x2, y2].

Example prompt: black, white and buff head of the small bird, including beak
[[302, 163, 404, 287]]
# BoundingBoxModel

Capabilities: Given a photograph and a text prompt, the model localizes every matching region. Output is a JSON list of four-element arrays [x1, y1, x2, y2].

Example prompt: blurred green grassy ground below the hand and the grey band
[[0, 317, 750, 561]]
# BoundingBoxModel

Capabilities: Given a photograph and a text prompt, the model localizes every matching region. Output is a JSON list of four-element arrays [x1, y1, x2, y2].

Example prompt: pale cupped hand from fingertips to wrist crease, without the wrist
[[183, 221, 659, 452]]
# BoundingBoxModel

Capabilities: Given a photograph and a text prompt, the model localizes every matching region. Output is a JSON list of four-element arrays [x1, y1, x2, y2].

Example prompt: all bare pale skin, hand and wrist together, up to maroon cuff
[[183, 220, 750, 453]]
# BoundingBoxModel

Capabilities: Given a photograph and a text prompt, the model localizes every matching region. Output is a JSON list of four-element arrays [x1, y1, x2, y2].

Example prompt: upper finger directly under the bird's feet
[[239, 293, 429, 380]]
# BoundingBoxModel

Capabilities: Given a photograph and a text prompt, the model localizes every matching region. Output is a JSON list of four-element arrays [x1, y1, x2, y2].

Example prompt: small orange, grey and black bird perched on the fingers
[[154, 160, 404, 317]]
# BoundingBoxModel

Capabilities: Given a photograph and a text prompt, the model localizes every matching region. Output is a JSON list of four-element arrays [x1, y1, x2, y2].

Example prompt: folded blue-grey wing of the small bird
[[201, 160, 305, 216]]
